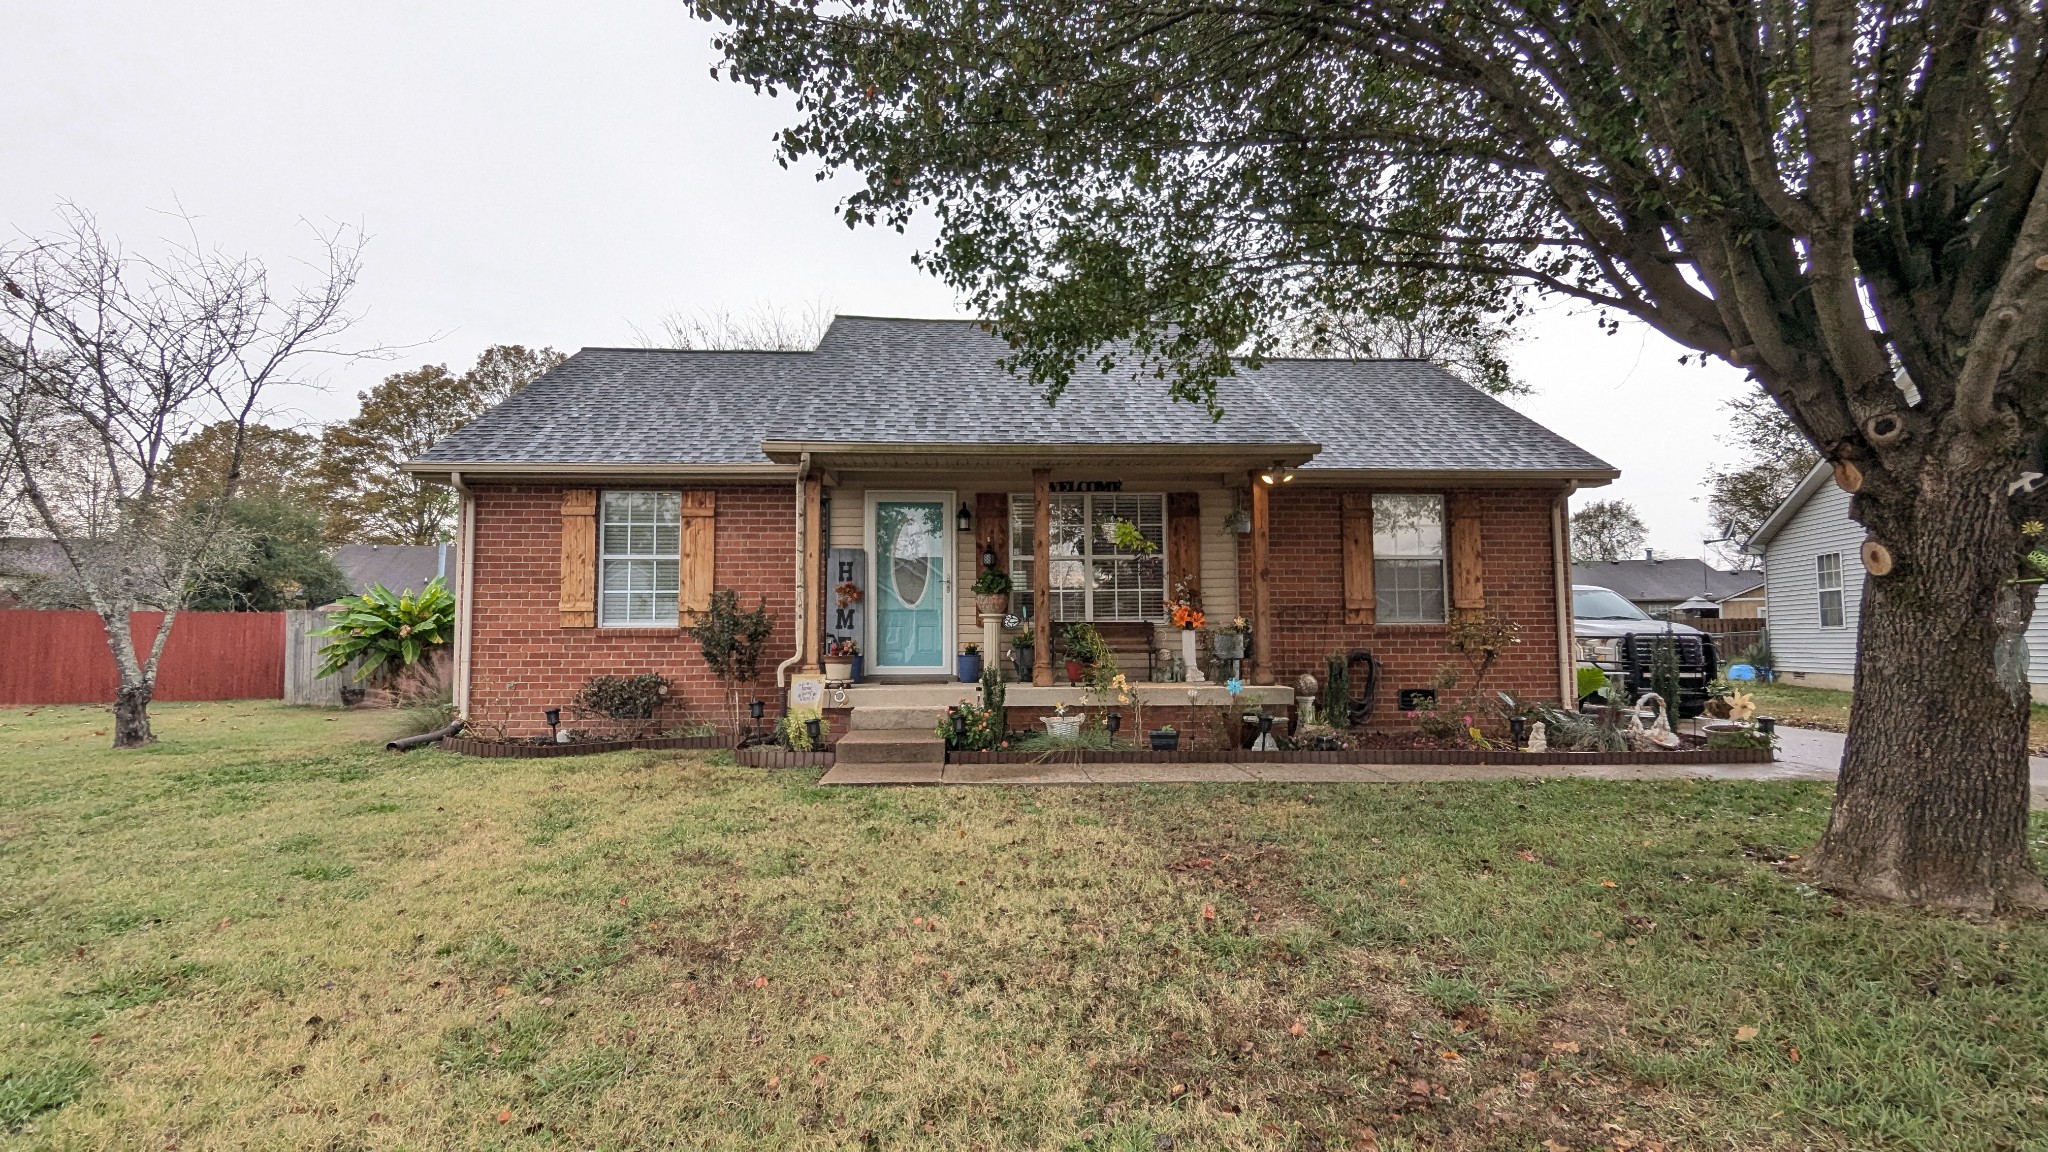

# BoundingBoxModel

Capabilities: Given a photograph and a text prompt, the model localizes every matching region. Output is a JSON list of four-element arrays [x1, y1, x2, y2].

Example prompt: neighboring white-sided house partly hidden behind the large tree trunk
[[1747, 461, 2048, 701]]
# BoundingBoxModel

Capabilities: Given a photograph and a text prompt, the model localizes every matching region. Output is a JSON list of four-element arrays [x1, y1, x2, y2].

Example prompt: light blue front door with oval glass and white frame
[[868, 498, 950, 672]]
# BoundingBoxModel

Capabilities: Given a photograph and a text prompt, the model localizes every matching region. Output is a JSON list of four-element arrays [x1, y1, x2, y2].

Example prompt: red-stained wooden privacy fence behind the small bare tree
[[0, 609, 285, 705]]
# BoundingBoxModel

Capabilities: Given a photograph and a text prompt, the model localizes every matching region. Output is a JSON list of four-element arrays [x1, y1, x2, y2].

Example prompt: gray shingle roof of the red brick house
[[414, 316, 1614, 476]]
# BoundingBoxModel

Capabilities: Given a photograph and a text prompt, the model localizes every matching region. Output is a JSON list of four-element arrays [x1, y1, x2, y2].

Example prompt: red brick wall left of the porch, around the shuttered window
[[469, 484, 797, 736]]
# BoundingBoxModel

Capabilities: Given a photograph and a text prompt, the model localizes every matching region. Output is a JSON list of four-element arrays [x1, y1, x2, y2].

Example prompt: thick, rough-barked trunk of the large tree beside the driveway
[[1794, 453, 2048, 912]]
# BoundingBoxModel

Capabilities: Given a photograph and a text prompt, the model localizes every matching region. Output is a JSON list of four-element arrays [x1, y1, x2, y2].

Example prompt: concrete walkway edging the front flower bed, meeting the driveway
[[817, 728, 2048, 808]]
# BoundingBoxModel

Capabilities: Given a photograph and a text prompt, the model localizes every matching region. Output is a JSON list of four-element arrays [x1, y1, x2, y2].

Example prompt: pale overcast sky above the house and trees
[[0, 0, 1745, 556]]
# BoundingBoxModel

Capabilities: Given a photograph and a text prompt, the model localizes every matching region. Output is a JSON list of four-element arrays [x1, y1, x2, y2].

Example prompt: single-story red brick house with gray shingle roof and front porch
[[408, 316, 1616, 734]]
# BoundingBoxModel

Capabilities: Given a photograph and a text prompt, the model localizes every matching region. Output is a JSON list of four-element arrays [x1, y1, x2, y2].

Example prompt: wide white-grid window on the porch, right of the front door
[[1010, 492, 1165, 623]]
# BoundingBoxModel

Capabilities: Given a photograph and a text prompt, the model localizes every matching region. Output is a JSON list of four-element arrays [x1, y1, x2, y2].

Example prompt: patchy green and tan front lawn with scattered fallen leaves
[[0, 703, 2048, 1152]]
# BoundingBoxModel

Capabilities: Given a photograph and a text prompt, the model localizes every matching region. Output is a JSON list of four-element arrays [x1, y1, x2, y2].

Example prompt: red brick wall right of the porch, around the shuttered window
[[1237, 486, 1559, 728]]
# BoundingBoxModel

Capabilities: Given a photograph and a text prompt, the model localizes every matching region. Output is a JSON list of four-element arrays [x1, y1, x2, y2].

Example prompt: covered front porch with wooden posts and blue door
[[764, 441, 1315, 688]]
